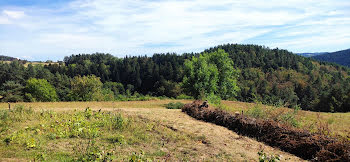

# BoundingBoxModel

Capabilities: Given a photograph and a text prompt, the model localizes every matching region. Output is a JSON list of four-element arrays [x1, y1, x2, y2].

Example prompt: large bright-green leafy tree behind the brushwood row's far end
[[182, 49, 239, 99]]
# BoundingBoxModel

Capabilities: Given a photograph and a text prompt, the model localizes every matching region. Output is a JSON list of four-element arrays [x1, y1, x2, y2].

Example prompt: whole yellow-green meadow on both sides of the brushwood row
[[0, 99, 350, 161]]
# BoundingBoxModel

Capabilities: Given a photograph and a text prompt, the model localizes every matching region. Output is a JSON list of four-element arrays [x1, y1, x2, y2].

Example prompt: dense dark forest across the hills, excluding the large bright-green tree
[[0, 44, 350, 112]]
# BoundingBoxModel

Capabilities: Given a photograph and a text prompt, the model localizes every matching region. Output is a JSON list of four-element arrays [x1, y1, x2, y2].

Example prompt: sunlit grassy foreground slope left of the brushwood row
[[0, 100, 300, 161]]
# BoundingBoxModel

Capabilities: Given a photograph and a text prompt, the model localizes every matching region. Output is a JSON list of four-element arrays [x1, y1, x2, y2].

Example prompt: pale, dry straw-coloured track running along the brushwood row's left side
[[115, 108, 302, 161]]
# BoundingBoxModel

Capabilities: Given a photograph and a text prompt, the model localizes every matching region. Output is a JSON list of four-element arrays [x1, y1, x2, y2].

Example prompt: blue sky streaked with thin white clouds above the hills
[[0, 0, 350, 61]]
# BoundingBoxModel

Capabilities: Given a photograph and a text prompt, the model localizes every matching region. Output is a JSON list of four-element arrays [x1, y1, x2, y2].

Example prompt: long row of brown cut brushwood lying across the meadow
[[182, 100, 350, 161]]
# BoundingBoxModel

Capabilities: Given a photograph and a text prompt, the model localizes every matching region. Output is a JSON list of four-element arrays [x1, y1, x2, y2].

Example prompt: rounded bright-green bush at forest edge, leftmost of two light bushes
[[25, 78, 58, 102]]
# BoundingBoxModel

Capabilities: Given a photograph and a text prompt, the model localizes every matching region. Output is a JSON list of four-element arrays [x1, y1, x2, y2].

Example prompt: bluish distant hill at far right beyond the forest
[[312, 49, 350, 67]]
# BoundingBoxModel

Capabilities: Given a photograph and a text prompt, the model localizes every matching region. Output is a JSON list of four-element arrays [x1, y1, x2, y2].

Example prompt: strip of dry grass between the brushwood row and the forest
[[221, 101, 350, 140]]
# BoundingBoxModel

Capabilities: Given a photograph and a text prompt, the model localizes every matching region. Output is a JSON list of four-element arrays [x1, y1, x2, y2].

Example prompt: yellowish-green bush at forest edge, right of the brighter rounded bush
[[70, 75, 103, 101]]
